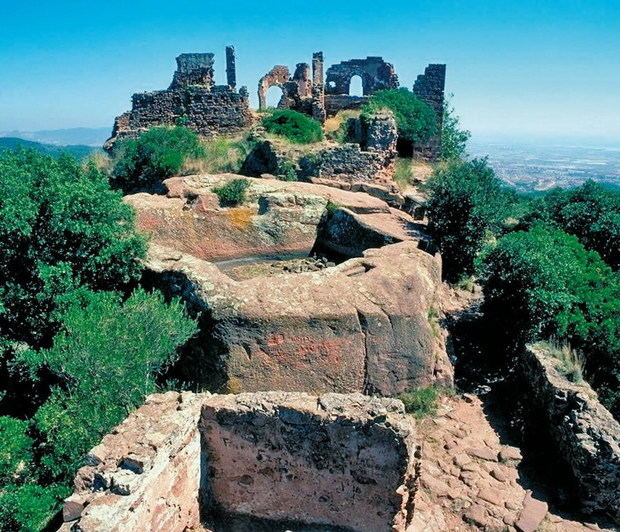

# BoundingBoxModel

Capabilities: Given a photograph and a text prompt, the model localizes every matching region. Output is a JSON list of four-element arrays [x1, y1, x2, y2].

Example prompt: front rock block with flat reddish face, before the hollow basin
[[148, 242, 452, 395]]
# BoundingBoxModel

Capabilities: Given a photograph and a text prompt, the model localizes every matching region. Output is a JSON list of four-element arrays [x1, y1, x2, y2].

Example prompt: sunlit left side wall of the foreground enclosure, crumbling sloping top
[[60, 392, 207, 532]]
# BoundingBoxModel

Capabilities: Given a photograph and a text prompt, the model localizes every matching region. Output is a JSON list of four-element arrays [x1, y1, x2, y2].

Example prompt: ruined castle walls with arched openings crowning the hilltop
[[104, 46, 446, 160]]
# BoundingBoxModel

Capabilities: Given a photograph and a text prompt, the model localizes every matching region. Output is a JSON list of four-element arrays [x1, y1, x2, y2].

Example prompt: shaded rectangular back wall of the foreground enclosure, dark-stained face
[[201, 392, 416, 532]]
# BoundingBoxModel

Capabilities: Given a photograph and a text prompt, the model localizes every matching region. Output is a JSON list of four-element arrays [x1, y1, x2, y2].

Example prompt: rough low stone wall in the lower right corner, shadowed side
[[519, 344, 620, 524]]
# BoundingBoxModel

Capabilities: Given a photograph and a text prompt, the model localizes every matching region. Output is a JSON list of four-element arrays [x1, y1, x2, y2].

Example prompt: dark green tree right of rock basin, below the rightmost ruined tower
[[427, 159, 512, 282]]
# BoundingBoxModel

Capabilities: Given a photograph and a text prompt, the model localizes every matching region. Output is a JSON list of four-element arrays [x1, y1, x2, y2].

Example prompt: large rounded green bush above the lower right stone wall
[[481, 226, 620, 416]]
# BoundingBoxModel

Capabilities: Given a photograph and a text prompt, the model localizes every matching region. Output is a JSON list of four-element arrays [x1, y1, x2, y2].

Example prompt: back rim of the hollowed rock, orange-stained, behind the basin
[[125, 174, 427, 261]]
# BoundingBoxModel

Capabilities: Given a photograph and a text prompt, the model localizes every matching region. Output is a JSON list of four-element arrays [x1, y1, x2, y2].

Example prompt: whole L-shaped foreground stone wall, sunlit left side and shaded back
[[60, 392, 418, 532]]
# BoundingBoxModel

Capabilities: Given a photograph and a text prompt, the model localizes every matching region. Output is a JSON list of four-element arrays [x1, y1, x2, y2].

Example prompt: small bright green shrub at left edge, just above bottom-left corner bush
[[0, 416, 34, 489]]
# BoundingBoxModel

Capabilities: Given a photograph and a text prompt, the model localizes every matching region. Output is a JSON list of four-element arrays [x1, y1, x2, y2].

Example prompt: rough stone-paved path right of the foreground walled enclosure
[[407, 394, 602, 532]]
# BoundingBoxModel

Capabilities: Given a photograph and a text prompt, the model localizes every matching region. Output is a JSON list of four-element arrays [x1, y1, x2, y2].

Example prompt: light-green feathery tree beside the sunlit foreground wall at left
[[21, 289, 196, 477]]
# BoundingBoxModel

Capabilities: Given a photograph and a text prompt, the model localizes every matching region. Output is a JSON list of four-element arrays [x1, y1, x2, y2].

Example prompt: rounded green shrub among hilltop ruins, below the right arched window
[[362, 87, 437, 142]]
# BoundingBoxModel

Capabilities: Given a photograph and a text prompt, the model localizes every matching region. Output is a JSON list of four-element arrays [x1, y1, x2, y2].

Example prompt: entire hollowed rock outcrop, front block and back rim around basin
[[126, 175, 452, 395]]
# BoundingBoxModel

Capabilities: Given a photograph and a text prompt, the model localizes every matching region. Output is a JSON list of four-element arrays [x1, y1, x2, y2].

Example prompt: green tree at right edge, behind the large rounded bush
[[524, 181, 620, 270]]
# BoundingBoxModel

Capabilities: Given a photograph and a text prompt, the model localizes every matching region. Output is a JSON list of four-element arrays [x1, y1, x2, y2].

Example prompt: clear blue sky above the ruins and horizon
[[0, 0, 620, 140]]
